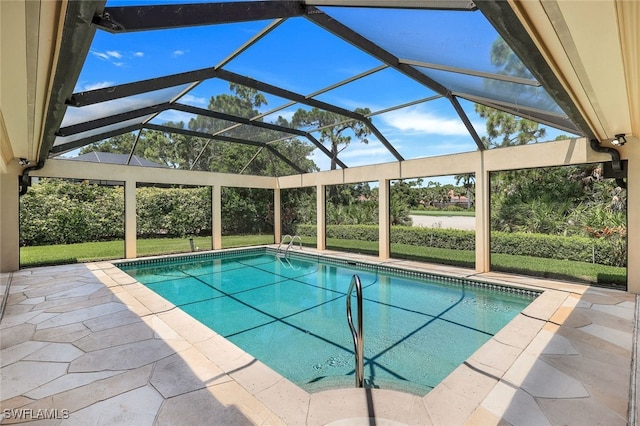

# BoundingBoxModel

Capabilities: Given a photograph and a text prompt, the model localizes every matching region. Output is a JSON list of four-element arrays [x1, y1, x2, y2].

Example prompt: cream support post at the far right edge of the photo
[[625, 156, 640, 294]]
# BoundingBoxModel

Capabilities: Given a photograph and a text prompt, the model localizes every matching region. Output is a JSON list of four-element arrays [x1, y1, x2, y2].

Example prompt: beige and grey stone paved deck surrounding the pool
[[0, 249, 637, 425]]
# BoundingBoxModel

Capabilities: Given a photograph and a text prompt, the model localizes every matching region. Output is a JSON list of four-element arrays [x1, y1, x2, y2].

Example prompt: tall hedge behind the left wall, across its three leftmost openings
[[20, 179, 273, 246]]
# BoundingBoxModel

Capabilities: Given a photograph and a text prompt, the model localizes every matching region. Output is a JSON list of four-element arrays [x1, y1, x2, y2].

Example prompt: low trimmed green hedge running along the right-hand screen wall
[[296, 225, 626, 267]]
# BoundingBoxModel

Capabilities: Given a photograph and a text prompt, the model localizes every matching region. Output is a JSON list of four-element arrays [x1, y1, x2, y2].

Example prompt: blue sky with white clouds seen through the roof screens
[[63, 2, 580, 180]]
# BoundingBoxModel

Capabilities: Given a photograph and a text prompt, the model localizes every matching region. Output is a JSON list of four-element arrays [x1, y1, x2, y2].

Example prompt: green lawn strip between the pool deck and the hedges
[[20, 235, 627, 288]]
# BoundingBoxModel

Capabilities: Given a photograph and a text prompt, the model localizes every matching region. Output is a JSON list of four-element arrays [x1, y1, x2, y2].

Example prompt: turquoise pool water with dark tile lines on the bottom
[[120, 250, 535, 395]]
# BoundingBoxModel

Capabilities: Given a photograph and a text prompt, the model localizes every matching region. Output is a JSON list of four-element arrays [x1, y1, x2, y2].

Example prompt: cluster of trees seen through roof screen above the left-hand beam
[[80, 83, 318, 176]]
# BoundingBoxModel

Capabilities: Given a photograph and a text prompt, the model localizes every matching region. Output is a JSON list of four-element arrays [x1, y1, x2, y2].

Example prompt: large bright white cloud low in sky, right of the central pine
[[380, 108, 476, 136]]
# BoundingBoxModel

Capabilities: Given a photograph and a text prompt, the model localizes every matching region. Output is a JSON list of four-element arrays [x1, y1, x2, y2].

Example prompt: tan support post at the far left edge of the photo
[[0, 165, 20, 272]]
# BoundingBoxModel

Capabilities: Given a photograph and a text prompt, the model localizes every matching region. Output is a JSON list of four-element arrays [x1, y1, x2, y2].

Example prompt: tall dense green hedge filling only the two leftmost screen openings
[[20, 180, 211, 246]]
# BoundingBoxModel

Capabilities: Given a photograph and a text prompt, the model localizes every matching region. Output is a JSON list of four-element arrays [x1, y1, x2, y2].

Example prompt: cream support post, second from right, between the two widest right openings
[[475, 156, 491, 272]]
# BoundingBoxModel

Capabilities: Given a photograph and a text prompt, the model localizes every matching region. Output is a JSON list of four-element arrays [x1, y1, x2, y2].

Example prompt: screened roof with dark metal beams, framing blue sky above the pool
[[50, 0, 590, 171]]
